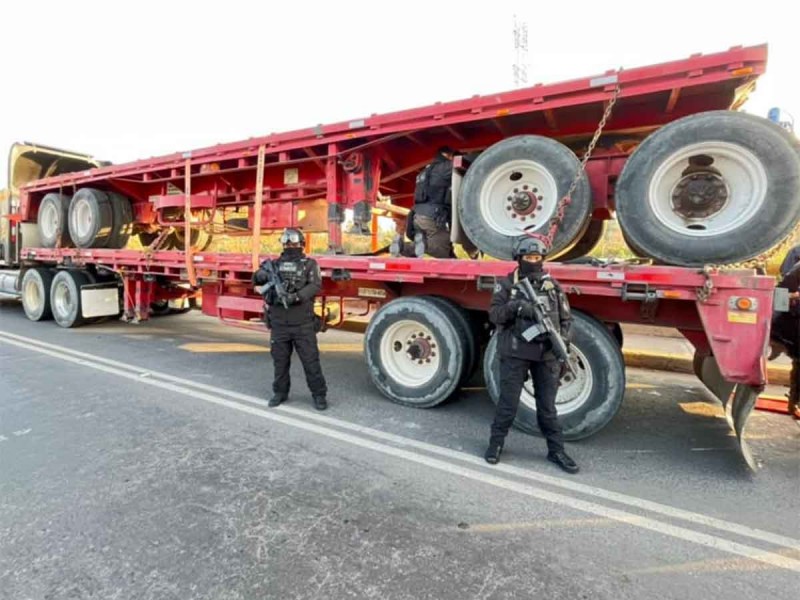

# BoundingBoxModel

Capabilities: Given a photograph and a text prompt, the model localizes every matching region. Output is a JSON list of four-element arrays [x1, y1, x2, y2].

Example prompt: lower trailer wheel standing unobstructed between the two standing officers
[[364, 297, 466, 408]]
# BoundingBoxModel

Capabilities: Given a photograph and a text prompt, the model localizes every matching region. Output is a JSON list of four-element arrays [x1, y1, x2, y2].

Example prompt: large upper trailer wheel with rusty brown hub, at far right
[[616, 111, 800, 267]]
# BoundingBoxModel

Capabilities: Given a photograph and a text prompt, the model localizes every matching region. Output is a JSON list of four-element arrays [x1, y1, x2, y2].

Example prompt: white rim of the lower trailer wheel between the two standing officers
[[380, 320, 442, 387]]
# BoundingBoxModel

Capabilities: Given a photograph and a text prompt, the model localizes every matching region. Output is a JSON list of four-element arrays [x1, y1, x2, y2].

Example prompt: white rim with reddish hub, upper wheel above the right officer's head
[[479, 159, 558, 236]]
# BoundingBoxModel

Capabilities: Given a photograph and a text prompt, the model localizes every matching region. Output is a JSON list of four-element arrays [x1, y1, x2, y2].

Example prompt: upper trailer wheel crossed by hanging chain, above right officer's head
[[458, 135, 592, 259]]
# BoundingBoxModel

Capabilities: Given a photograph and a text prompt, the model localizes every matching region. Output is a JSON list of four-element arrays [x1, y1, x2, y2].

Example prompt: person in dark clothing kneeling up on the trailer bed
[[390, 146, 456, 258]]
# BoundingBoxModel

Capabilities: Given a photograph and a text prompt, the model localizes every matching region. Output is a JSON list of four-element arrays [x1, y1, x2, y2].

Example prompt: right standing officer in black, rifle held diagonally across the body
[[484, 237, 578, 473]]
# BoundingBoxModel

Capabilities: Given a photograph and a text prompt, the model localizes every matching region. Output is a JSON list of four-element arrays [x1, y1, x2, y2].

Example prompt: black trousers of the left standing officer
[[269, 321, 328, 396]]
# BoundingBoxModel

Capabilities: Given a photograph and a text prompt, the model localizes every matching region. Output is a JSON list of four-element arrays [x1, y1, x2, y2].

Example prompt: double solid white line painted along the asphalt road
[[0, 332, 800, 572]]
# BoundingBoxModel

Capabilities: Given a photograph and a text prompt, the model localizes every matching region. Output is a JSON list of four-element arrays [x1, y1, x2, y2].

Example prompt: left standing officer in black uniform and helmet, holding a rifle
[[253, 228, 328, 410]]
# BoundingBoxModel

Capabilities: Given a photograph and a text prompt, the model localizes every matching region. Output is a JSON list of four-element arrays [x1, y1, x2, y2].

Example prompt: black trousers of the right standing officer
[[489, 356, 564, 452]]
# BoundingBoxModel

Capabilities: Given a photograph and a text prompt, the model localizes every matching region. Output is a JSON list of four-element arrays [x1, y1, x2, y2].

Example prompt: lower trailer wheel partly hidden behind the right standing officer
[[483, 311, 625, 440]]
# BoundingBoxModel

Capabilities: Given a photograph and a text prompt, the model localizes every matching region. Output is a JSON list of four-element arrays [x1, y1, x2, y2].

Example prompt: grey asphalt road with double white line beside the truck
[[0, 303, 800, 600]]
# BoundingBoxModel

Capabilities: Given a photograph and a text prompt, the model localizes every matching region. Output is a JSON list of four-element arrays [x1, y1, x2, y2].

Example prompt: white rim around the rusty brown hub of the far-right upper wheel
[[647, 142, 767, 238]]
